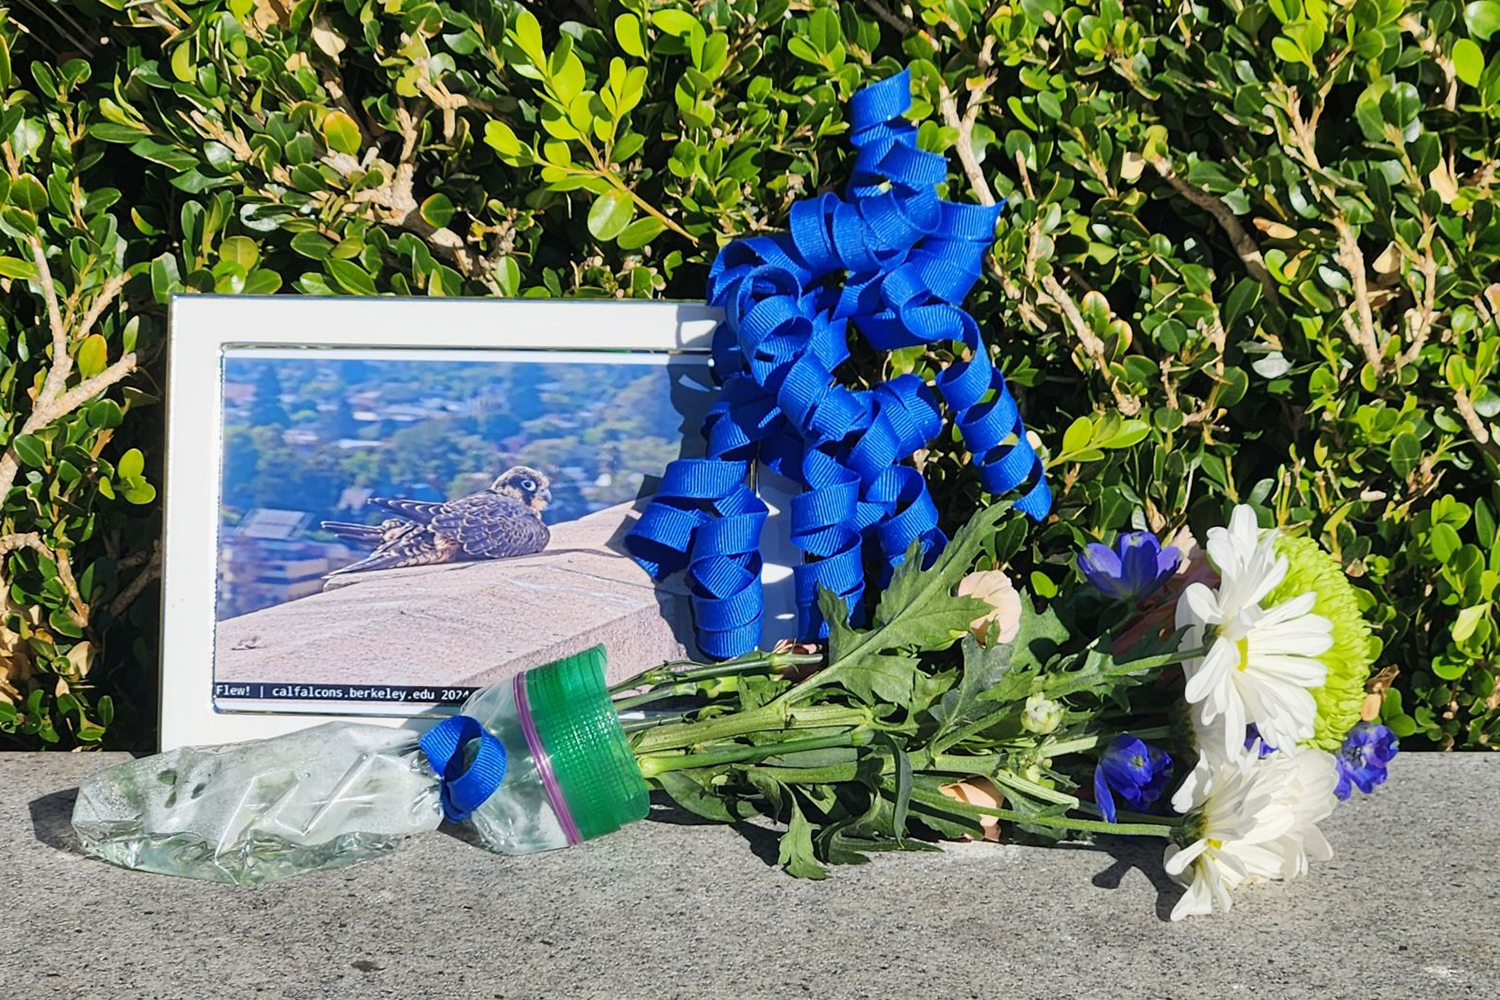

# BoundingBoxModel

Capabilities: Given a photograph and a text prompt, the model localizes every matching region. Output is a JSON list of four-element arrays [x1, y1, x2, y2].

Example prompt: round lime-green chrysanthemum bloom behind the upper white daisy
[[1263, 535, 1374, 753]]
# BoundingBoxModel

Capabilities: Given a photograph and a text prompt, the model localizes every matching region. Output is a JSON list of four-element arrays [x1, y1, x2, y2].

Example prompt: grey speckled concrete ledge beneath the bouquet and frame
[[0, 754, 1500, 1000]]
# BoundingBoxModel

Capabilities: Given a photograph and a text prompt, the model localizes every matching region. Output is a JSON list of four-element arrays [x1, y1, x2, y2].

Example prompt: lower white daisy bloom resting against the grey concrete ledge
[[1166, 747, 1338, 921]]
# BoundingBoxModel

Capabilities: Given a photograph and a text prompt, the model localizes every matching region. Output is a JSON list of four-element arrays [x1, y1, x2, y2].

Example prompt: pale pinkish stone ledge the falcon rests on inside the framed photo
[[215, 504, 692, 687]]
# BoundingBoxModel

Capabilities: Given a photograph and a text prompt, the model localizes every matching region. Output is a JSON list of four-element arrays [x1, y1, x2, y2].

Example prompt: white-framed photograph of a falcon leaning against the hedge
[[161, 295, 791, 748]]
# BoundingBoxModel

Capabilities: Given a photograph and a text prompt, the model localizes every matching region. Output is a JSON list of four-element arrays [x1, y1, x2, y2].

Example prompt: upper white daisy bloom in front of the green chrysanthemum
[[1178, 505, 1332, 756]]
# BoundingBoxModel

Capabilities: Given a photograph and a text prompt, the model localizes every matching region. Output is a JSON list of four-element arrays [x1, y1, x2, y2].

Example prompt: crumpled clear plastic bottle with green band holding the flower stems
[[74, 646, 650, 885]]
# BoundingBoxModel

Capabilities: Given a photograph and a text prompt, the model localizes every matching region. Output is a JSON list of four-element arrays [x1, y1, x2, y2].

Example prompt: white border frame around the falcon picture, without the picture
[[159, 295, 794, 750]]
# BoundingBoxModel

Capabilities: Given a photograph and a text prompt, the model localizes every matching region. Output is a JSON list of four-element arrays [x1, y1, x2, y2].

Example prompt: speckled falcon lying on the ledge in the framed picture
[[321, 465, 552, 576]]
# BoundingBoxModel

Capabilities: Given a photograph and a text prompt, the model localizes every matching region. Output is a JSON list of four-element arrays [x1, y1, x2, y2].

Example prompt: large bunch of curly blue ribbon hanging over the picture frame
[[627, 70, 1052, 658]]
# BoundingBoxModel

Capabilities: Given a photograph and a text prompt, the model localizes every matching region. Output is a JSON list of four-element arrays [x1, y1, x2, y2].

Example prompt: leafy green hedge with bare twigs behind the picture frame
[[0, 0, 1500, 747]]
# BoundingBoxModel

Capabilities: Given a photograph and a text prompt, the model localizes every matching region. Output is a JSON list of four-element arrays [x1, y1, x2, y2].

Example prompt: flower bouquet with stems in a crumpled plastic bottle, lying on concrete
[[74, 505, 1397, 919]]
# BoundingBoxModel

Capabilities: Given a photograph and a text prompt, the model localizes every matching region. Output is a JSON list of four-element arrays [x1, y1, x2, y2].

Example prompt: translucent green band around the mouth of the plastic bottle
[[527, 646, 651, 840]]
